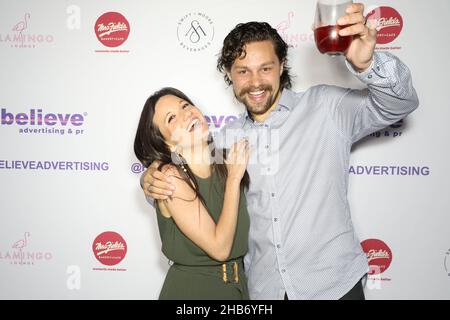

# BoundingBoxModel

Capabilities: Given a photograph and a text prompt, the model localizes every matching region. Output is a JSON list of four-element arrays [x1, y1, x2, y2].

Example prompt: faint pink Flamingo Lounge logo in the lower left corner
[[0, 232, 53, 266]]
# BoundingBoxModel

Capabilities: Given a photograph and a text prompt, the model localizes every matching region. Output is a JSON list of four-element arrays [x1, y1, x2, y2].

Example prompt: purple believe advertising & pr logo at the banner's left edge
[[0, 108, 87, 135]]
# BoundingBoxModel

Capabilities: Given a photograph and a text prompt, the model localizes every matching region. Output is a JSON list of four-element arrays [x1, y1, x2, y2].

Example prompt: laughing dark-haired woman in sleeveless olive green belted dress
[[134, 88, 253, 299]]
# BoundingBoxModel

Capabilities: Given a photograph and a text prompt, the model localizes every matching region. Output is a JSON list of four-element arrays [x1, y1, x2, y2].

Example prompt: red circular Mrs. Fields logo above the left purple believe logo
[[94, 12, 130, 48]]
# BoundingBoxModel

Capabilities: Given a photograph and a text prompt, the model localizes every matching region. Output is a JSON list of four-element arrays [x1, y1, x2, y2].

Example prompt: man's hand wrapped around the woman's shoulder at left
[[142, 161, 175, 200]]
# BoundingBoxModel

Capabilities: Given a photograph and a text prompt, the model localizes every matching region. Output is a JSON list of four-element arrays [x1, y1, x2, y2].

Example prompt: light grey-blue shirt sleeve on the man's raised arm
[[324, 53, 419, 143]]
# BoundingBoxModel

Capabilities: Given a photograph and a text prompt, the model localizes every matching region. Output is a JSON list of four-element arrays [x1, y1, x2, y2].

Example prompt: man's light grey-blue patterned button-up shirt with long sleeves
[[215, 53, 418, 299]]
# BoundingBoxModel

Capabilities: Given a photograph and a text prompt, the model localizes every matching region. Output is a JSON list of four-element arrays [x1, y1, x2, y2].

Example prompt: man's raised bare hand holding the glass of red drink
[[338, 3, 377, 72]]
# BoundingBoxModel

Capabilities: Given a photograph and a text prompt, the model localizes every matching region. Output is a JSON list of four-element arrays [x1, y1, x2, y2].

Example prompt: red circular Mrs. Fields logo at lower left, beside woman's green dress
[[92, 231, 127, 266]]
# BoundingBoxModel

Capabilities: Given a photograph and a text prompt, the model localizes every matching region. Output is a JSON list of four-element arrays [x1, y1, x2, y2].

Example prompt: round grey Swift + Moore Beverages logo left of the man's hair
[[177, 12, 214, 52]]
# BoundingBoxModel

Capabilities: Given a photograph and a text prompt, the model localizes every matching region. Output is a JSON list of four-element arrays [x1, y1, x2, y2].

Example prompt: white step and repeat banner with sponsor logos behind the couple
[[0, 0, 450, 299]]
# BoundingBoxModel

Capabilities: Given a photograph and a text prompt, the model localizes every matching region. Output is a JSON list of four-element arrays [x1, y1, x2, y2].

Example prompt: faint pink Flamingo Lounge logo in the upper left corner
[[0, 12, 55, 49]]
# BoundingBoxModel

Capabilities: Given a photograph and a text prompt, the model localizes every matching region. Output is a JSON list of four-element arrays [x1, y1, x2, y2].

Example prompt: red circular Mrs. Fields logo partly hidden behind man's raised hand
[[367, 7, 403, 44]]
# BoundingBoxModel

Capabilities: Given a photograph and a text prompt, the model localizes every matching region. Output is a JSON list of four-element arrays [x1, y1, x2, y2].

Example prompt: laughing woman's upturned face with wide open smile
[[153, 95, 209, 151]]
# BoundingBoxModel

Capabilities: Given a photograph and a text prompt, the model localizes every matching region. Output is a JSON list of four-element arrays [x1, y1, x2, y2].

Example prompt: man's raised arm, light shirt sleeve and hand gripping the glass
[[322, 3, 419, 143]]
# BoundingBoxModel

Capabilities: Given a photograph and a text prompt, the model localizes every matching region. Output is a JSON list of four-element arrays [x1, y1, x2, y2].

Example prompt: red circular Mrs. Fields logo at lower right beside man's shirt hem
[[361, 239, 392, 275]]
